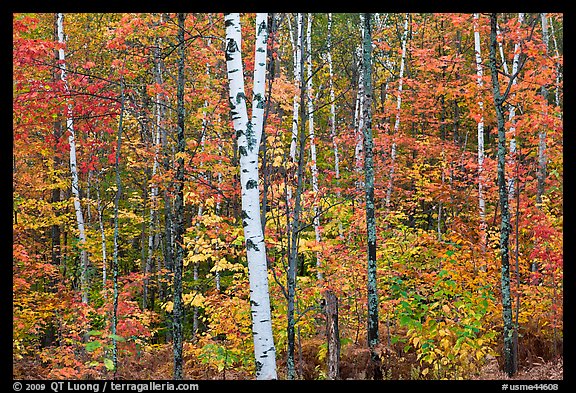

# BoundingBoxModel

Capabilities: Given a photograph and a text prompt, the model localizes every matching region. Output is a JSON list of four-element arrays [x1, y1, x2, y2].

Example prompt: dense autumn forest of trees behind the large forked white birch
[[12, 13, 563, 379]]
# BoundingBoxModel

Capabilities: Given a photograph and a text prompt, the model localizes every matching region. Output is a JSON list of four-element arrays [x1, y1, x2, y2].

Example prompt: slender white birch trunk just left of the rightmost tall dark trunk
[[474, 14, 486, 252]]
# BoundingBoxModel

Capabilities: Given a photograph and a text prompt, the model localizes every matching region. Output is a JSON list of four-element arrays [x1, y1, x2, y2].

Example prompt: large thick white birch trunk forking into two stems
[[225, 13, 277, 379]]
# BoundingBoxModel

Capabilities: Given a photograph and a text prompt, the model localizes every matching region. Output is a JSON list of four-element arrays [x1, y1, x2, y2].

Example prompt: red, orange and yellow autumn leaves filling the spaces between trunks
[[13, 14, 563, 378]]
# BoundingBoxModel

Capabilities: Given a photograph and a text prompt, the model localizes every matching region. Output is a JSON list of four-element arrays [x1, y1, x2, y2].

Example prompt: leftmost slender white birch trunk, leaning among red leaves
[[57, 13, 88, 304]]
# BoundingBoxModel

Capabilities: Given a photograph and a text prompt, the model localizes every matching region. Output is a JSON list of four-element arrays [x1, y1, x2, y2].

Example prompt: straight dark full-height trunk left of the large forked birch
[[172, 13, 186, 379]]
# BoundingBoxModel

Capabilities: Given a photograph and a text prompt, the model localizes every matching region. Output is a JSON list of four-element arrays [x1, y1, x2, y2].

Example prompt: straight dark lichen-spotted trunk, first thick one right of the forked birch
[[362, 14, 382, 379]]
